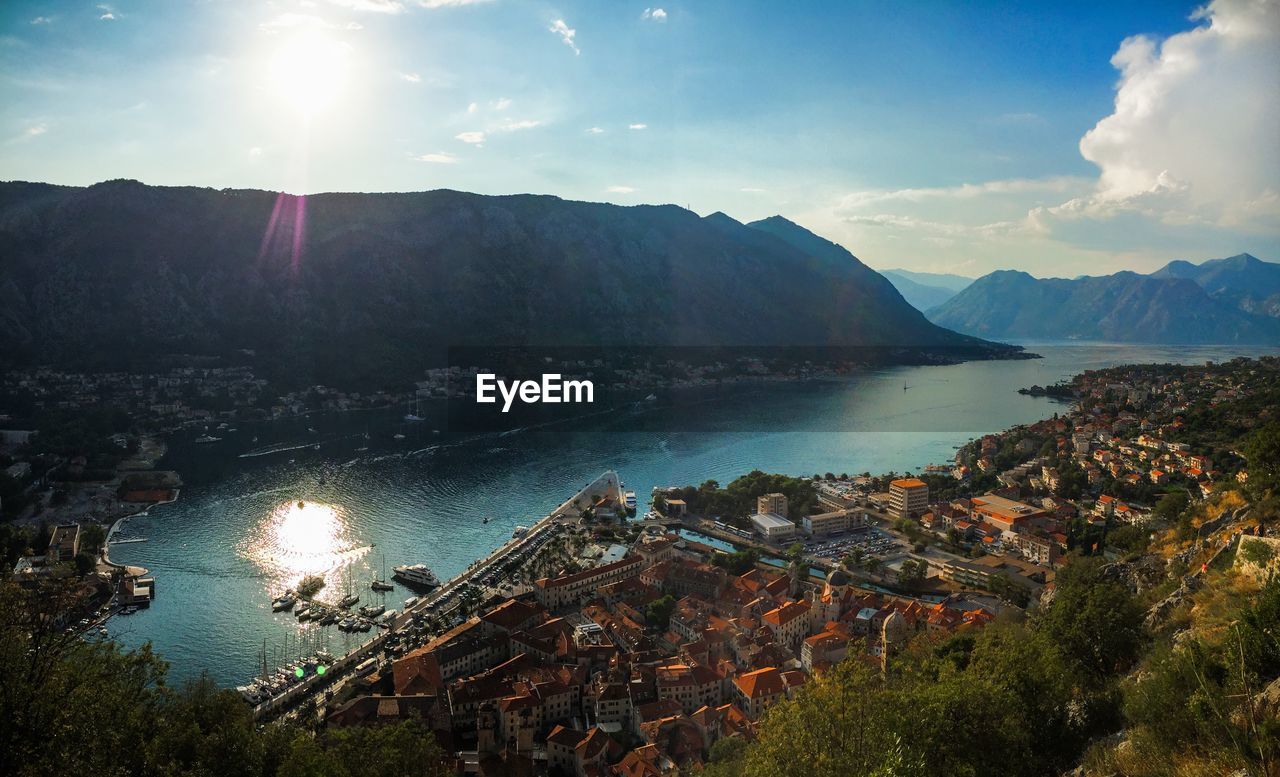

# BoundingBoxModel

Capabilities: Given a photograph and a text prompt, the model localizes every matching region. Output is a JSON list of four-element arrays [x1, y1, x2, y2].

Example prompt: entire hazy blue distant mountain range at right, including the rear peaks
[[928, 253, 1280, 344]]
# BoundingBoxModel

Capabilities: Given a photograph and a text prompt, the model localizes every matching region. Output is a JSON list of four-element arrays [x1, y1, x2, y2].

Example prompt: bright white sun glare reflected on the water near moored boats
[[239, 502, 370, 600]]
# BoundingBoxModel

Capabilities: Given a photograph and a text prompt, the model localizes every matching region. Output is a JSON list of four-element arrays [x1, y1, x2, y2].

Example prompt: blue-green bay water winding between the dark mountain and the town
[[111, 344, 1276, 685]]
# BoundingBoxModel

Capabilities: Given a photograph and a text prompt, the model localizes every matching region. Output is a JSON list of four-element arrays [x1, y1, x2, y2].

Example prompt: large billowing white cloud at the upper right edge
[[1064, 0, 1280, 233]]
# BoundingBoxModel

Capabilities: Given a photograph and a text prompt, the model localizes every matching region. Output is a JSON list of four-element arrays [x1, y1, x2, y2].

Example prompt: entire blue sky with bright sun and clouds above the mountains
[[0, 0, 1280, 276]]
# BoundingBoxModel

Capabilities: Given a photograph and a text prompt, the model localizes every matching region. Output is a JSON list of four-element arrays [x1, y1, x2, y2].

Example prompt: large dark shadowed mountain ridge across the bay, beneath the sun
[[0, 180, 1009, 385]]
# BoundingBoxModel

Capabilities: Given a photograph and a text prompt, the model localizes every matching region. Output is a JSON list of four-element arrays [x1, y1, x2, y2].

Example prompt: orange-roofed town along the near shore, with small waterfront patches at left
[[10, 358, 1280, 776]]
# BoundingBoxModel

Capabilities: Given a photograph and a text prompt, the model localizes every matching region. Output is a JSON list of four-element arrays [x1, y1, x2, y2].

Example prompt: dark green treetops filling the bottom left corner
[[0, 582, 452, 777]]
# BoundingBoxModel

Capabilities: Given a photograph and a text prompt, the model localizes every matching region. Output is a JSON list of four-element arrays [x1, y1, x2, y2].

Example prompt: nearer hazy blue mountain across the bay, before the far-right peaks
[[928, 270, 1280, 343]]
